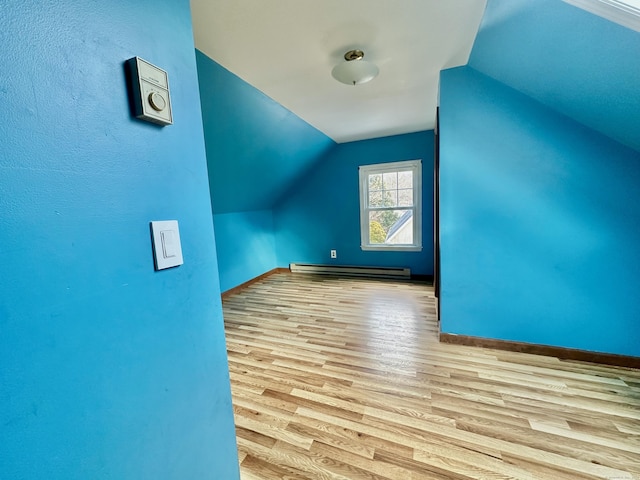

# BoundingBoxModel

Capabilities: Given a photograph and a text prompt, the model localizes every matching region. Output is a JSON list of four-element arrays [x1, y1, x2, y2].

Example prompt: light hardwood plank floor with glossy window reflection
[[223, 273, 640, 480]]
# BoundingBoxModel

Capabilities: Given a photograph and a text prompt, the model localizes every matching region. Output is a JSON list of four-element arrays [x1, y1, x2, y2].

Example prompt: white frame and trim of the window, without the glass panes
[[359, 159, 422, 252]]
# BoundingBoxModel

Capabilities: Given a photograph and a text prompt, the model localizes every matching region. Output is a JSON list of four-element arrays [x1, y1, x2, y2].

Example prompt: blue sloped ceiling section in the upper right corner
[[469, 0, 640, 151]]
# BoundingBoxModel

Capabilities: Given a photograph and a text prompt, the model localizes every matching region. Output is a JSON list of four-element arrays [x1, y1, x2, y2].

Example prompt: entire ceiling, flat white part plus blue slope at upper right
[[191, 0, 640, 150]]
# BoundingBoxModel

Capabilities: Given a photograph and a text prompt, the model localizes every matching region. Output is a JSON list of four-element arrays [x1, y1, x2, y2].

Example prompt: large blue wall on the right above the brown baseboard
[[440, 67, 640, 356]]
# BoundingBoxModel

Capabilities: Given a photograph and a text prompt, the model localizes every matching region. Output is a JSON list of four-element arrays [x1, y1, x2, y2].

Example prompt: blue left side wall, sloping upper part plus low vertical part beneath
[[196, 50, 335, 291]]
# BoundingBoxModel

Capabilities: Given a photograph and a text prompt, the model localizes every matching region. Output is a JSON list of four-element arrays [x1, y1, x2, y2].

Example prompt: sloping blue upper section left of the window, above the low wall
[[196, 51, 335, 214]]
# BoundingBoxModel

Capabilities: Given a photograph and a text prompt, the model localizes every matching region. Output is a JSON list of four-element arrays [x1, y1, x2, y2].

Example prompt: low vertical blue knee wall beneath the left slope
[[213, 210, 278, 292]]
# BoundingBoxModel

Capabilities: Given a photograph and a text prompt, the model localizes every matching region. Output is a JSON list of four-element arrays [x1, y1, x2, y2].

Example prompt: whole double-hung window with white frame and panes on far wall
[[360, 160, 422, 251]]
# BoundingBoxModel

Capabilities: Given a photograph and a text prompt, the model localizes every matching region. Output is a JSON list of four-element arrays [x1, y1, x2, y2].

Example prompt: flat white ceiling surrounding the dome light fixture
[[191, 0, 486, 143]]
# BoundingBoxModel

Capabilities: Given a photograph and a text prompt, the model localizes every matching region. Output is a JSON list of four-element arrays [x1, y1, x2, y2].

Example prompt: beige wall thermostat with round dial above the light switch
[[127, 57, 173, 125]]
